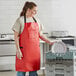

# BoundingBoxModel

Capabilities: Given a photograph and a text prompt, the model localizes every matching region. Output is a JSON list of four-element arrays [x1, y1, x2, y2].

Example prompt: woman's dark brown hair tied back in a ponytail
[[20, 1, 37, 16]]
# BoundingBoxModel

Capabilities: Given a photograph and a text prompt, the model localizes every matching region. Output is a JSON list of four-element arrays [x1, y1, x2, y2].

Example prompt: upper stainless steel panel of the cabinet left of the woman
[[0, 41, 16, 56]]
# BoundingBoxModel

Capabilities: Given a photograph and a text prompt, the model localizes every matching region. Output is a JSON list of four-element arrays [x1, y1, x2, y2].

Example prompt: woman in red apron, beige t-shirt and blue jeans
[[12, 2, 52, 76]]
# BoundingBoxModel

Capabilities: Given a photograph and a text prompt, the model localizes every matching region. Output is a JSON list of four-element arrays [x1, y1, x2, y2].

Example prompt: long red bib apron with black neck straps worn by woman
[[15, 16, 40, 72]]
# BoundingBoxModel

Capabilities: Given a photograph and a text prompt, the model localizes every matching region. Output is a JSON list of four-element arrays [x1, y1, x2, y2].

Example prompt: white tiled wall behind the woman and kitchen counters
[[0, 0, 76, 35]]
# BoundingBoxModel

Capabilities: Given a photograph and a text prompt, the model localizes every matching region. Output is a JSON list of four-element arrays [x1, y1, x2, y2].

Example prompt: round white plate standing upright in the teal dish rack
[[51, 42, 67, 53]]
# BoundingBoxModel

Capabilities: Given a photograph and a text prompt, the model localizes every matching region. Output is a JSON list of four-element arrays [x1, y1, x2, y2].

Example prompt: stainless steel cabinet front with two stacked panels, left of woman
[[0, 39, 16, 71]]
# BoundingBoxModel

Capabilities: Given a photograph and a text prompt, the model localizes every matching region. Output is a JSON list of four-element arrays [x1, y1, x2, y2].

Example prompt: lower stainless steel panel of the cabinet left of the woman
[[0, 56, 15, 71]]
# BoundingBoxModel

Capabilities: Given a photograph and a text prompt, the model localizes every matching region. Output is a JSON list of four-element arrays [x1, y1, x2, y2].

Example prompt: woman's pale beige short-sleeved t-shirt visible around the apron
[[12, 16, 43, 34]]
